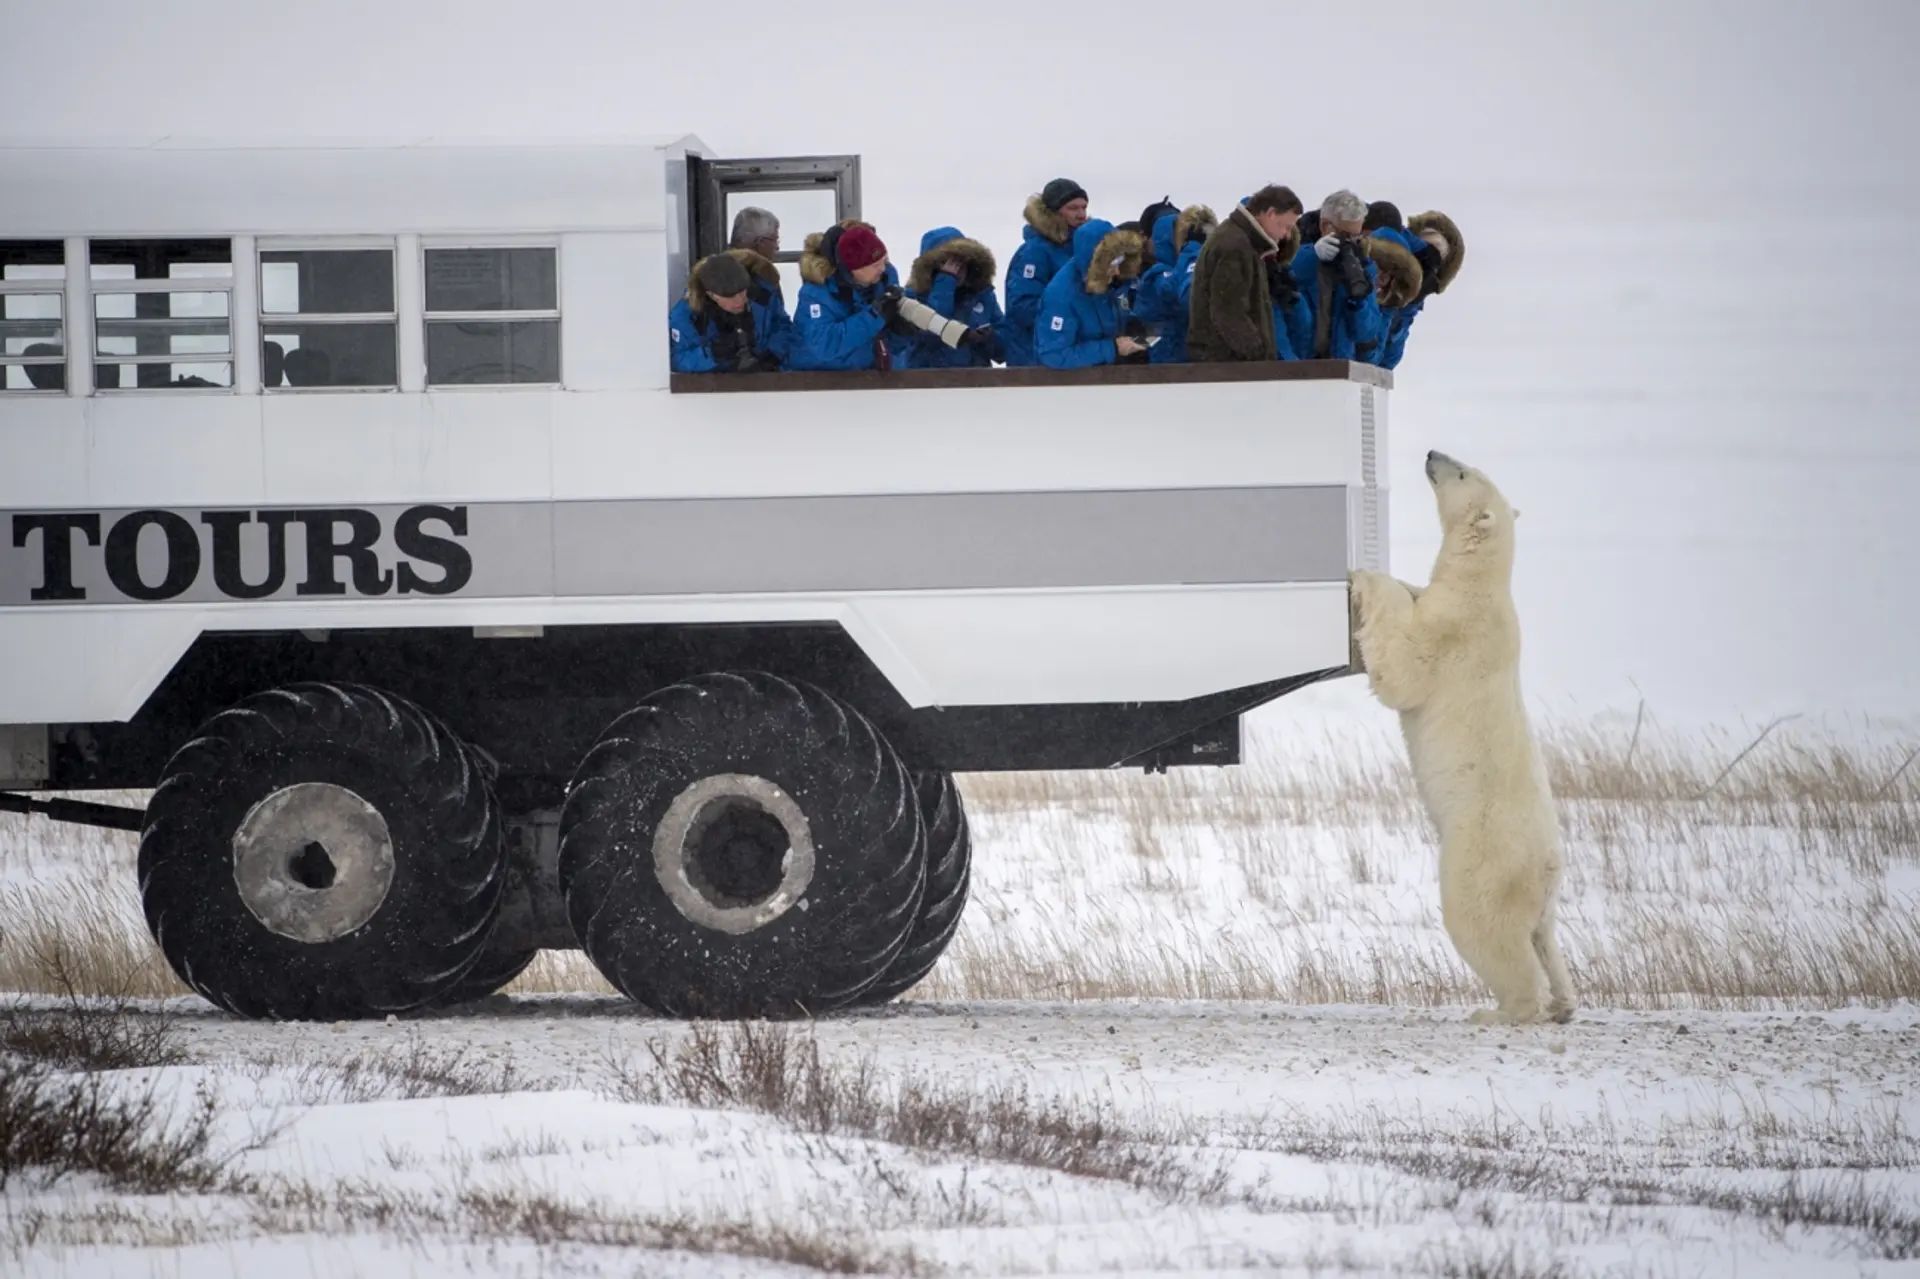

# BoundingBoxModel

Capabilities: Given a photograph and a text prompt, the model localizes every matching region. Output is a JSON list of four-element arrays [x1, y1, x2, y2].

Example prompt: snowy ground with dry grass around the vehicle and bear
[[0, 709, 1920, 1275]]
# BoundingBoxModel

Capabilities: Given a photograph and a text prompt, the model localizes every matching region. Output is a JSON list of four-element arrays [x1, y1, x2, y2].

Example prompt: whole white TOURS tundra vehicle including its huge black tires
[[0, 136, 1390, 1020]]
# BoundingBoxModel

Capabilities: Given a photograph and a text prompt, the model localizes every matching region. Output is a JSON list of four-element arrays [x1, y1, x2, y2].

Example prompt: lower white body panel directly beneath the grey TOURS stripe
[[0, 584, 1348, 724]]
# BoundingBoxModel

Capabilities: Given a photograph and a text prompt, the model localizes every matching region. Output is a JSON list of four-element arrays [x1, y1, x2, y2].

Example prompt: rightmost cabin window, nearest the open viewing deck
[[426, 248, 561, 386]]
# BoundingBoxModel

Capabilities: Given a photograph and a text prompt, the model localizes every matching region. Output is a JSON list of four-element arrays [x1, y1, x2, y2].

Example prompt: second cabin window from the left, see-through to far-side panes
[[88, 240, 234, 390]]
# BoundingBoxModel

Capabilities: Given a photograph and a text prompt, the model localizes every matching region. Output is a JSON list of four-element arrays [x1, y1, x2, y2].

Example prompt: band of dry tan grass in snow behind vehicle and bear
[[0, 720, 1920, 1008]]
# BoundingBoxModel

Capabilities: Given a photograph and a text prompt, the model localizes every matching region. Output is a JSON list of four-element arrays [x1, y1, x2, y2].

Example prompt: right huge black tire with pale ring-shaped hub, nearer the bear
[[561, 672, 925, 1018]]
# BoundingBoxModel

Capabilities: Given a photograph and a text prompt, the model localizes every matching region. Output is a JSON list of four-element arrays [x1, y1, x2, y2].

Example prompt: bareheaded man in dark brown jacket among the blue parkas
[[1187, 184, 1300, 363]]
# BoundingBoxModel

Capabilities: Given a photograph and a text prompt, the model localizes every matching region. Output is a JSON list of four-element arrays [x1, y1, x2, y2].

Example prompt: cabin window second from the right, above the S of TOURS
[[259, 248, 399, 390]]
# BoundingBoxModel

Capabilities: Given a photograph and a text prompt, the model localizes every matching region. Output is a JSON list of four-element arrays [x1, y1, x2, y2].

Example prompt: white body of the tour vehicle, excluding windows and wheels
[[0, 138, 1390, 789]]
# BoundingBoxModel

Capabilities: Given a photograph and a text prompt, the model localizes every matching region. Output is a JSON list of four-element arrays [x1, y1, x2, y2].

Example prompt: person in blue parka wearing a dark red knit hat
[[787, 219, 910, 369]]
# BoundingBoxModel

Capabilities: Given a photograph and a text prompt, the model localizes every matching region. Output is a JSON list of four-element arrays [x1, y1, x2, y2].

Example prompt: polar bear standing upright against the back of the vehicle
[[1350, 453, 1574, 1024]]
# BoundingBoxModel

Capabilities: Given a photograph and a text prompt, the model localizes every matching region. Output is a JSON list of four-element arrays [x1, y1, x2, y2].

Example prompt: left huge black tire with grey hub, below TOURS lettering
[[140, 684, 505, 1020]]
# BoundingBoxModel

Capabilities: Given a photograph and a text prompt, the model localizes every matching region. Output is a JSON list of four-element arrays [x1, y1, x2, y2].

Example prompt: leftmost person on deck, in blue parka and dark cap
[[666, 250, 793, 373]]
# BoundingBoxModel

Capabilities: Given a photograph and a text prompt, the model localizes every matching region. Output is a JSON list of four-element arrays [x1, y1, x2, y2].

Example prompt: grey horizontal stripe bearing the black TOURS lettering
[[0, 484, 1350, 605]]
